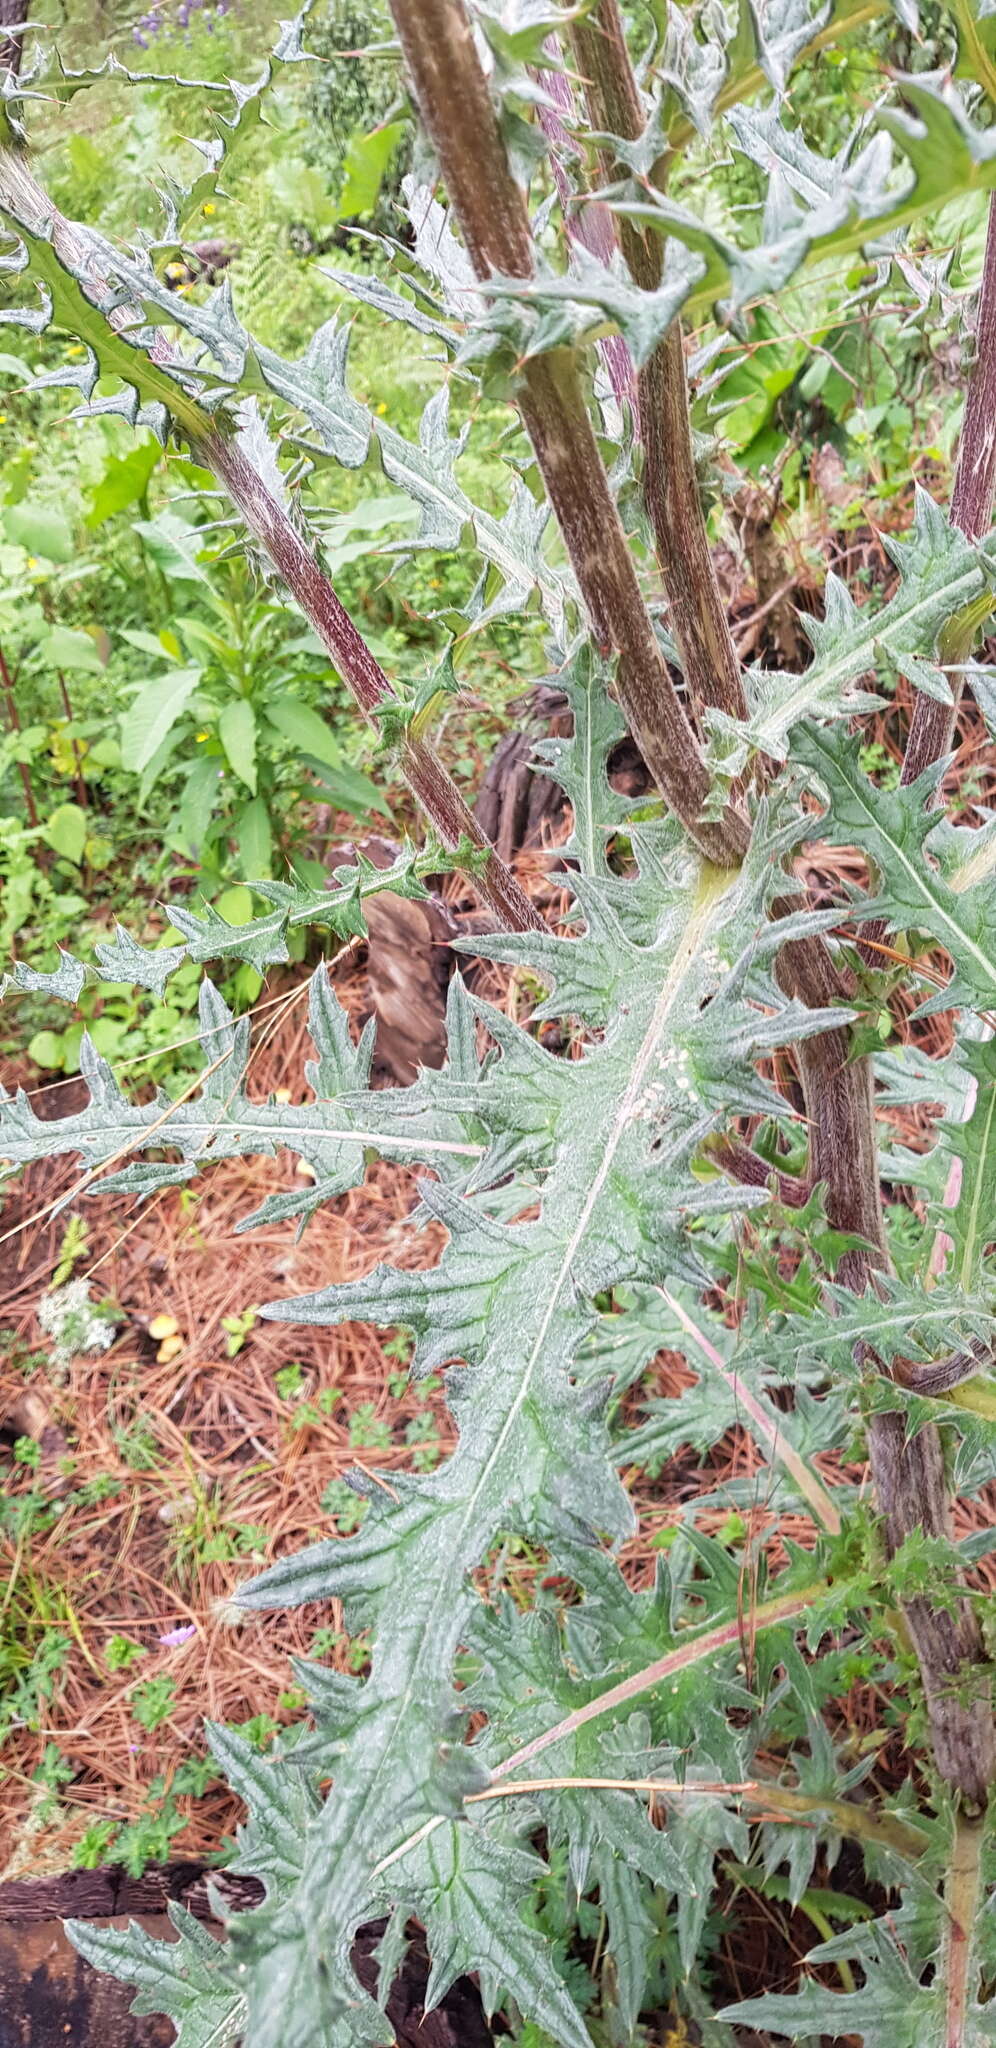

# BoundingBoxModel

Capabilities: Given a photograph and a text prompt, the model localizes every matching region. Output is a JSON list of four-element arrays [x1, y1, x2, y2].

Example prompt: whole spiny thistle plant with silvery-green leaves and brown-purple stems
[[0, 0, 996, 2048]]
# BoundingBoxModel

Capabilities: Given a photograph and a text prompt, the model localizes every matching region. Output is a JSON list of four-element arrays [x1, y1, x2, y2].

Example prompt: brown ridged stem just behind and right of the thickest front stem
[[572, 0, 746, 719]]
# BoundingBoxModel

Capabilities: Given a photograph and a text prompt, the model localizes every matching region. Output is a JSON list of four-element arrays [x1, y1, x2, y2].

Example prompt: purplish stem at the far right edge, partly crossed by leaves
[[902, 195, 996, 782]]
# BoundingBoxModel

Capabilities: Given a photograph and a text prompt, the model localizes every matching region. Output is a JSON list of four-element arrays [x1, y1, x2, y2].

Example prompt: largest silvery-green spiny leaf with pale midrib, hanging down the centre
[[194, 839, 848, 2048]]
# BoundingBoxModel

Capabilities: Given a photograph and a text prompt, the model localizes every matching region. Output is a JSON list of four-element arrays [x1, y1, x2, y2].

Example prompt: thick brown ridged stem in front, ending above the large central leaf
[[391, 0, 748, 866]]
